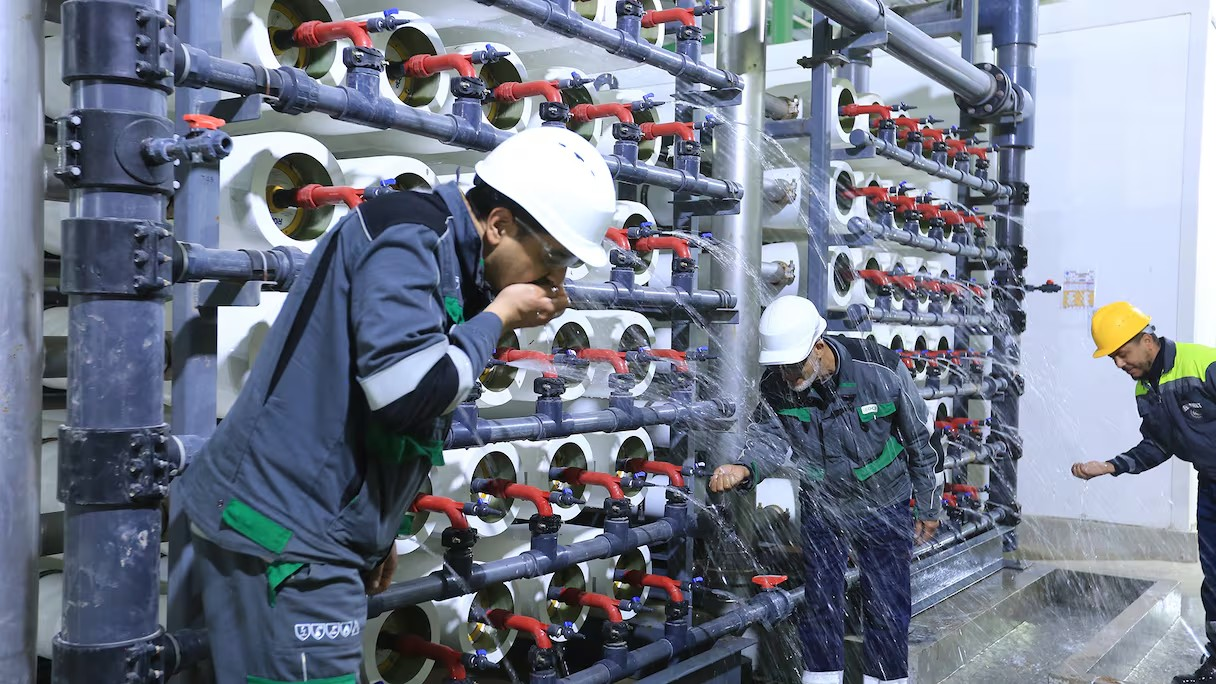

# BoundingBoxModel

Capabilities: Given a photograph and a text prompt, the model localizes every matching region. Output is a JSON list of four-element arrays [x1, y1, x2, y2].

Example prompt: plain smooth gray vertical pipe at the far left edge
[[0, 0, 43, 684]]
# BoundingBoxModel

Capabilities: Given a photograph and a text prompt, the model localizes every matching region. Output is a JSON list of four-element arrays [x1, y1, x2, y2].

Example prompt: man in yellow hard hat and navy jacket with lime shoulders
[[1073, 302, 1216, 684]]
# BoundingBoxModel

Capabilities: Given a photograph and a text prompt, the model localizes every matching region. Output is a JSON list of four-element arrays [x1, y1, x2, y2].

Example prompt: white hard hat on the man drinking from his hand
[[474, 125, 617, 267]]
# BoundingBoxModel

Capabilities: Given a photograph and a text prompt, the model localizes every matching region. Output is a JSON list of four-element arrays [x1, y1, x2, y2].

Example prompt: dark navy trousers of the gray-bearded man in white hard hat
[[798, 499, 912, 682]]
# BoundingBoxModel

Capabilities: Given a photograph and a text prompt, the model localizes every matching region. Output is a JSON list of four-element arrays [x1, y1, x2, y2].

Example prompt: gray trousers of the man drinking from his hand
[[195, 534, 367, 684]]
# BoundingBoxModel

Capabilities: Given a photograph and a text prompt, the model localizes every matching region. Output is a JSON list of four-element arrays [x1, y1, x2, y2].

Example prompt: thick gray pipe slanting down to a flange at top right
[[804, 0, 997, 105]]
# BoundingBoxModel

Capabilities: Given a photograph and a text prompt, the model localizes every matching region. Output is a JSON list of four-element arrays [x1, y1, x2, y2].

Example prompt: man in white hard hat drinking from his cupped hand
[[174, 128, 615, 684]]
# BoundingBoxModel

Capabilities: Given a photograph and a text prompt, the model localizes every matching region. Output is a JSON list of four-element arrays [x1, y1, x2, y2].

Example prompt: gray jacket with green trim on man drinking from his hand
[[174, 184, 502, 567]]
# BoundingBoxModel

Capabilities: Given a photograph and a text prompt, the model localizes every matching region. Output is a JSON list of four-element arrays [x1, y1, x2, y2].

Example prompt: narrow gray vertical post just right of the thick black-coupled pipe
[[165, 0, 221, 684]]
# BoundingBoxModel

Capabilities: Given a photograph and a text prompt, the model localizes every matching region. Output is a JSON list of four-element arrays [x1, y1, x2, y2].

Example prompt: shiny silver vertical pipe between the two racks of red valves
[[708, 1, 766, 595]]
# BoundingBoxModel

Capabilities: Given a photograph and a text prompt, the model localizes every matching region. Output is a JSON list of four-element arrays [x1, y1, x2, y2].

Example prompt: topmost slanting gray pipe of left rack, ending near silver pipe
[[477, 0, 741, 88]]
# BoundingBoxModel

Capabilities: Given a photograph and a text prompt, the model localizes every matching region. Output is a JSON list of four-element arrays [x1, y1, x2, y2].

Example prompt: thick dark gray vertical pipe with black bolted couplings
[[54, 0, 171, 684]]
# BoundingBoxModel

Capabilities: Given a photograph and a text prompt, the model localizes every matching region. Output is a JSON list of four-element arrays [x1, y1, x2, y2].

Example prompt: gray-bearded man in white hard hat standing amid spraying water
[[709, 297, 941, 684]]
